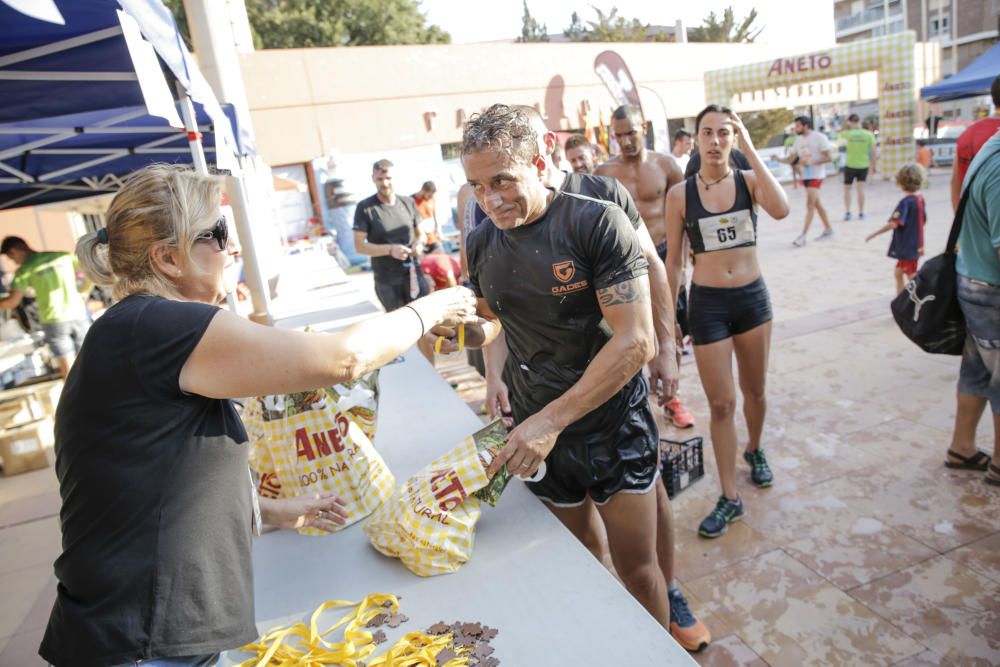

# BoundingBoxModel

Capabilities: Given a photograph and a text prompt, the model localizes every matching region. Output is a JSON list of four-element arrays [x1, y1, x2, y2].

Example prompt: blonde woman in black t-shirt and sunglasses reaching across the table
[[39, 165, 475, 667]]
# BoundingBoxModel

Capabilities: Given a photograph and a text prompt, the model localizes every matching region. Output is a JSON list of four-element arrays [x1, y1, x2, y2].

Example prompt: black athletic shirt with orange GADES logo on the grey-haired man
[[468, 192, 648, 440]]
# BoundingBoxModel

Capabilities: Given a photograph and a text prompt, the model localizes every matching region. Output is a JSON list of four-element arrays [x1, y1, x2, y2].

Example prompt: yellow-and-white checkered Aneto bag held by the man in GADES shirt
[[365, 436, 490, 577]]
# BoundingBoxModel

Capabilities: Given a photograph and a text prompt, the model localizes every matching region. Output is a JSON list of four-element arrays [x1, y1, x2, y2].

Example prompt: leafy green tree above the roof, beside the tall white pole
[[165, 0, 451, 49]]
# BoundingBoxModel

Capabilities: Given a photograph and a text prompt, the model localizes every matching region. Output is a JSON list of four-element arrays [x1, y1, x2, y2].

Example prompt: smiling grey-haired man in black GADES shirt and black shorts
[[462, 104, 669, 629]]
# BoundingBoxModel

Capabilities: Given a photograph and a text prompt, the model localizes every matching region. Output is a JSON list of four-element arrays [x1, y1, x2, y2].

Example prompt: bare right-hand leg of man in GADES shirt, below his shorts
[[597, 488, 670, 632]]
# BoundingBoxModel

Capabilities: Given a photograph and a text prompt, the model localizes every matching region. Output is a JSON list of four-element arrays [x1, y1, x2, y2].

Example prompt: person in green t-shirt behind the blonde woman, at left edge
[[0, 236, 90, 377]]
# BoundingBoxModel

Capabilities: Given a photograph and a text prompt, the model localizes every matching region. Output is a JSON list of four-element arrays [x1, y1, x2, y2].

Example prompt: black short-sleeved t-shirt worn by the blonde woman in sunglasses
[[39, 295, 257, 667]]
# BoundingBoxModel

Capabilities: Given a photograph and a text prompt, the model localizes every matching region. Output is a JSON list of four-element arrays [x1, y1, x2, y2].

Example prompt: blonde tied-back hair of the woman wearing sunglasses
[[76, 164, 221, 299]]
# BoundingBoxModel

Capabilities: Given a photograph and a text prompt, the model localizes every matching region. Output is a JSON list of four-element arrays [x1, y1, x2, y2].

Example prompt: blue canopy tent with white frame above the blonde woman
[[0, 0, 270, 321]]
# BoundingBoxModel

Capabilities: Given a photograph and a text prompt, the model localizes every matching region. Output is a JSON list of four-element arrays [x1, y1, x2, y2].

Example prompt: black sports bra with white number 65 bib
[[684, 169, 757, 255]]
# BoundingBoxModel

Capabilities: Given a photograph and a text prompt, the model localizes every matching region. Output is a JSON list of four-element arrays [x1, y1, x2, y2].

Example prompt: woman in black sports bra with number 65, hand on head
[[667, 104, 788, 537]]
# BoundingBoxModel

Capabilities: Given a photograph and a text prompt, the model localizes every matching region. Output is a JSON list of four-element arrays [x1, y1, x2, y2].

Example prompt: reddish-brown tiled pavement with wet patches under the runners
[[0, 172, 1000, 667]]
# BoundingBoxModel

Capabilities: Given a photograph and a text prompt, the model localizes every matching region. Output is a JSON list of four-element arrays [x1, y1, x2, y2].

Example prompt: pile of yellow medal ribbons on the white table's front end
[[240, 593, 469, 667]]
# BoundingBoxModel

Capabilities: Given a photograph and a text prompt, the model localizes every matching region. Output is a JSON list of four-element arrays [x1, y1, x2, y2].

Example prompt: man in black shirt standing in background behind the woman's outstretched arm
[[354, 160, 429, 312]]
